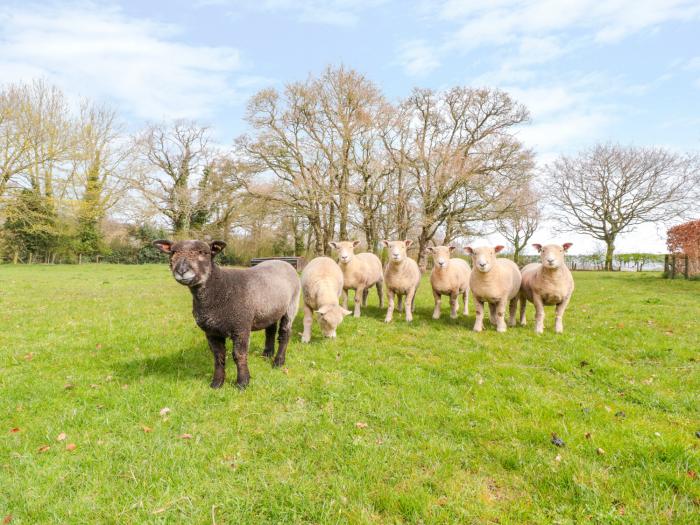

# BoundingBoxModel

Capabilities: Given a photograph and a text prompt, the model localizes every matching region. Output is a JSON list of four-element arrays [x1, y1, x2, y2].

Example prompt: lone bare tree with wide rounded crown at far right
[[547, 144, 698, 271]]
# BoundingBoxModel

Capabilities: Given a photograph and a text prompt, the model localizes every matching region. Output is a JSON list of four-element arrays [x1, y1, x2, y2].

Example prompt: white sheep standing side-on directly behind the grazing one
[[328, 241, 384, 317]]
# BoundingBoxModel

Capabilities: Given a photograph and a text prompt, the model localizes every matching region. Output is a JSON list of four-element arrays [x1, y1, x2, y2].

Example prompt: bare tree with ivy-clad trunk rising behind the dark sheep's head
[[132, 120, 212, 237]]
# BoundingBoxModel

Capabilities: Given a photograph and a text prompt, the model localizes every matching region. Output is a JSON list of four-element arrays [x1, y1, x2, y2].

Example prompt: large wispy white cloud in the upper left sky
[[0, 3, 246, 120]]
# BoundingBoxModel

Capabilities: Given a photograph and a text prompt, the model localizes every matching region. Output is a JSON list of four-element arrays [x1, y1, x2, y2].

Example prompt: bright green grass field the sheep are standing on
[[0, 265, 700, 524]]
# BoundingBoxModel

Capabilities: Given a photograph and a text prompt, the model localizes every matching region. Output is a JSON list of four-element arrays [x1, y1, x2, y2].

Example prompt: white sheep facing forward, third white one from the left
[[382, 240, 420, 323]]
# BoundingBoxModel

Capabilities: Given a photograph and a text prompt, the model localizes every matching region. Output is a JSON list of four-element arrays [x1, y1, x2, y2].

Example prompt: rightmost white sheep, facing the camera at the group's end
[[520, 242, 574, 334]]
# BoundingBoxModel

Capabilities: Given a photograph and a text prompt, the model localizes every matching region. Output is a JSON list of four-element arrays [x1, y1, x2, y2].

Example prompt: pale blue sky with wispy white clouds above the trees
[[0, 0, 700, 249]]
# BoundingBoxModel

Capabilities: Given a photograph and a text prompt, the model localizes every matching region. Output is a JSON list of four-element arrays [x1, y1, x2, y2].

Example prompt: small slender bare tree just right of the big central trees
[[495, 186, 542, 264]]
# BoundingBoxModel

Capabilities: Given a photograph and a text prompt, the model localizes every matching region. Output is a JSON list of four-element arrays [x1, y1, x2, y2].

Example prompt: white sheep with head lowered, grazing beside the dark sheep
[[301, 257, 352, 343]]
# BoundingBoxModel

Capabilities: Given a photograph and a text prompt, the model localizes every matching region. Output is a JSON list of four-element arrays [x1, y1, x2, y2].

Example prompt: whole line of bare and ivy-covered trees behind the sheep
[[0, 67, 697, 269]]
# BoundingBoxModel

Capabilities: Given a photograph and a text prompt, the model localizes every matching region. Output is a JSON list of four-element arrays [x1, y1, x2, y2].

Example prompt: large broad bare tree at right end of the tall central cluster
[[403, 87, 532, 269]]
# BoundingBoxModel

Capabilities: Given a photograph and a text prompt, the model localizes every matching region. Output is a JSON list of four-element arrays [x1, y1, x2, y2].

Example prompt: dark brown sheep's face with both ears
[[153, 240, 226, 287]]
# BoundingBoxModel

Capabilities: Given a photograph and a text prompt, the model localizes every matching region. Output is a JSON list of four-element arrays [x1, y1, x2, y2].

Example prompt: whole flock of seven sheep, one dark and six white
[[154, 240, 574, 388]]
